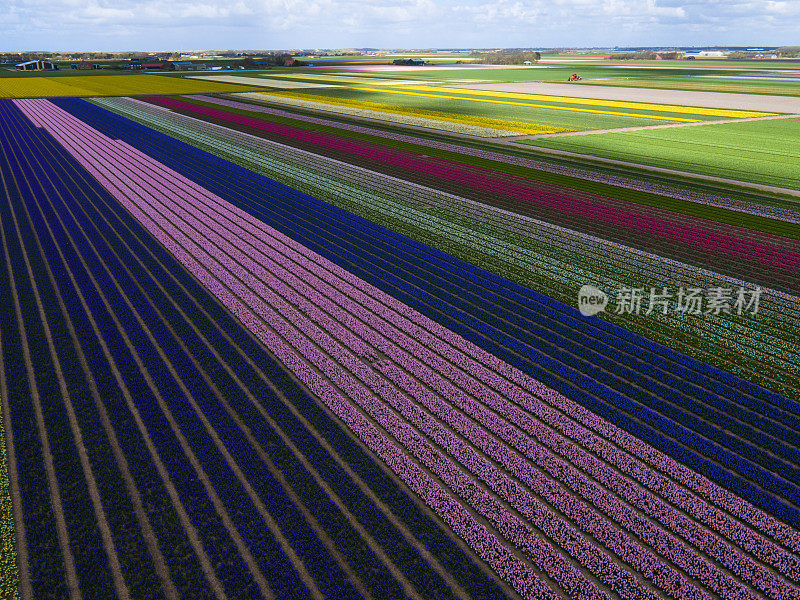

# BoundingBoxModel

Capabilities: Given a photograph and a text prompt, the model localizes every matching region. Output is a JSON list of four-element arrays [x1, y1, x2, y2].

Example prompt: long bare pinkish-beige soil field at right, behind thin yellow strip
[[454, 81, 800, 113]]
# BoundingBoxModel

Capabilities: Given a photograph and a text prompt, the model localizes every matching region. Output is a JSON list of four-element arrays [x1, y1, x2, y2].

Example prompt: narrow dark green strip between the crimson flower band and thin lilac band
[[180, 98, 800, 239]]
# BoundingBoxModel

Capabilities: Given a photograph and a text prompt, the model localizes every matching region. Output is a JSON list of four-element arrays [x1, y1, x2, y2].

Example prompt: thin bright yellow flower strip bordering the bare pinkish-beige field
[[403, 85, 775, 119]]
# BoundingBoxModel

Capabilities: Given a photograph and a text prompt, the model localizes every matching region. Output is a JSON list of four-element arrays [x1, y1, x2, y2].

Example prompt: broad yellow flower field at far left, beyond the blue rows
[[0, 74, 263, 98]]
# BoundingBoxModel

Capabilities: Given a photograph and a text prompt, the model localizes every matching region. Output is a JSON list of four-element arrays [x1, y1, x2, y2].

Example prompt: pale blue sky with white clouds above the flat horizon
[[0, 0, 800, 50]]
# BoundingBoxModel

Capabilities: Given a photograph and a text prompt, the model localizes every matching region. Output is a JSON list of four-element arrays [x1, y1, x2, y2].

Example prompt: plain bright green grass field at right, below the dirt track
[[524, 119, 800, 189]]
